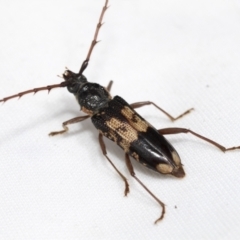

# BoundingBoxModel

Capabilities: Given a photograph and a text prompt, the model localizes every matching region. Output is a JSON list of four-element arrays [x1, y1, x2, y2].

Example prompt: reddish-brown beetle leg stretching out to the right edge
[[158, 128, 240, 152]]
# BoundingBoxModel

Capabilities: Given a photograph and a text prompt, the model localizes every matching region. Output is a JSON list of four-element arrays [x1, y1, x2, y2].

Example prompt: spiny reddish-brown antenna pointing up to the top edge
[[79, 0, 108, 75]]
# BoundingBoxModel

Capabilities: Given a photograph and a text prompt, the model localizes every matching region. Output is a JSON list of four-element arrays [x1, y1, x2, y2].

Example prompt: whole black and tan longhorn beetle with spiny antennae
[[0, 0, 240, 223]]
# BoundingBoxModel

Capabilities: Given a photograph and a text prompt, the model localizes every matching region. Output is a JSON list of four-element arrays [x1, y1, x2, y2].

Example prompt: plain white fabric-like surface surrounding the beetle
[[0, 0, 240, 239]]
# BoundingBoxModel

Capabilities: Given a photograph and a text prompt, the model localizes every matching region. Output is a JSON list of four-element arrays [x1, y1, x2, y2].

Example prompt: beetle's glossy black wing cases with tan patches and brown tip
[[92, 96, 185, 177]]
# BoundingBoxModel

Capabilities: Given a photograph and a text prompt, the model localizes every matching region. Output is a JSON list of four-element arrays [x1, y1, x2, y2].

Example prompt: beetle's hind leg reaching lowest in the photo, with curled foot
[[125, 153, 165, 224]]
